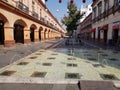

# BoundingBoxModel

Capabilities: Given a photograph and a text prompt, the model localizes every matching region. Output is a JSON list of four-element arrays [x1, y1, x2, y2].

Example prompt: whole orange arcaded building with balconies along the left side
[[0, 0, 64, 47]]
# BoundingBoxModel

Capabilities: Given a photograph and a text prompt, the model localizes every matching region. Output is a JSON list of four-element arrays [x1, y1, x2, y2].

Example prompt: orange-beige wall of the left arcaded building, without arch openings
[[0, 0, 63, 46]]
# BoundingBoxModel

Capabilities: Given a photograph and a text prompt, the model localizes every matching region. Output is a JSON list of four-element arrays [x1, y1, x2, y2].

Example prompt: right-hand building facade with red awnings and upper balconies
[[92, 0, 120, 45]]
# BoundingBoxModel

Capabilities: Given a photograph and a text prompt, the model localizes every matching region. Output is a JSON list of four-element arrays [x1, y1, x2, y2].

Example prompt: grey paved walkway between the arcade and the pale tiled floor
[[0, 39, 62, 68]]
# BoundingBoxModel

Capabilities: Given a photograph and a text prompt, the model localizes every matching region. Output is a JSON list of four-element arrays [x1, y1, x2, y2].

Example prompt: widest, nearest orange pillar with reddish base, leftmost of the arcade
[[4, 27, 15, 47]]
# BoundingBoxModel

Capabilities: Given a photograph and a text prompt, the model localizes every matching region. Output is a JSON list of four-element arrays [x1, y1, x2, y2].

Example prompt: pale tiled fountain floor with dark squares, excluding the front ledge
[[0, 49, 120, 80]]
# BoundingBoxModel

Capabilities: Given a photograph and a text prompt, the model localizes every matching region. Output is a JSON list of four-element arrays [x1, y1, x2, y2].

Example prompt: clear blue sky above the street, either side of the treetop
[[45, 0, 92, 21]]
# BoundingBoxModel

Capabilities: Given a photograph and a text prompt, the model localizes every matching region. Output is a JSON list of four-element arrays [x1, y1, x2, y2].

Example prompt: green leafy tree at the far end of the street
[[61, 2, 82, 35]]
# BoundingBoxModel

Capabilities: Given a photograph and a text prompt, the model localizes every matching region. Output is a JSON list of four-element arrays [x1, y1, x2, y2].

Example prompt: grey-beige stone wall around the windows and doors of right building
[[92, 0, 120, 43]]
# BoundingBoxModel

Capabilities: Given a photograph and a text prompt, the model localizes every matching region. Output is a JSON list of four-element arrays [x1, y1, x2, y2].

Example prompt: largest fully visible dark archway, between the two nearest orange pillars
[[14, 20, 27, 43]]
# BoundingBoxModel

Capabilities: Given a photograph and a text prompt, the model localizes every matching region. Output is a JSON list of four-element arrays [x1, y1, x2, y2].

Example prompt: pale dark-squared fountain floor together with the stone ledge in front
[[0, 38, 120, 90]]
